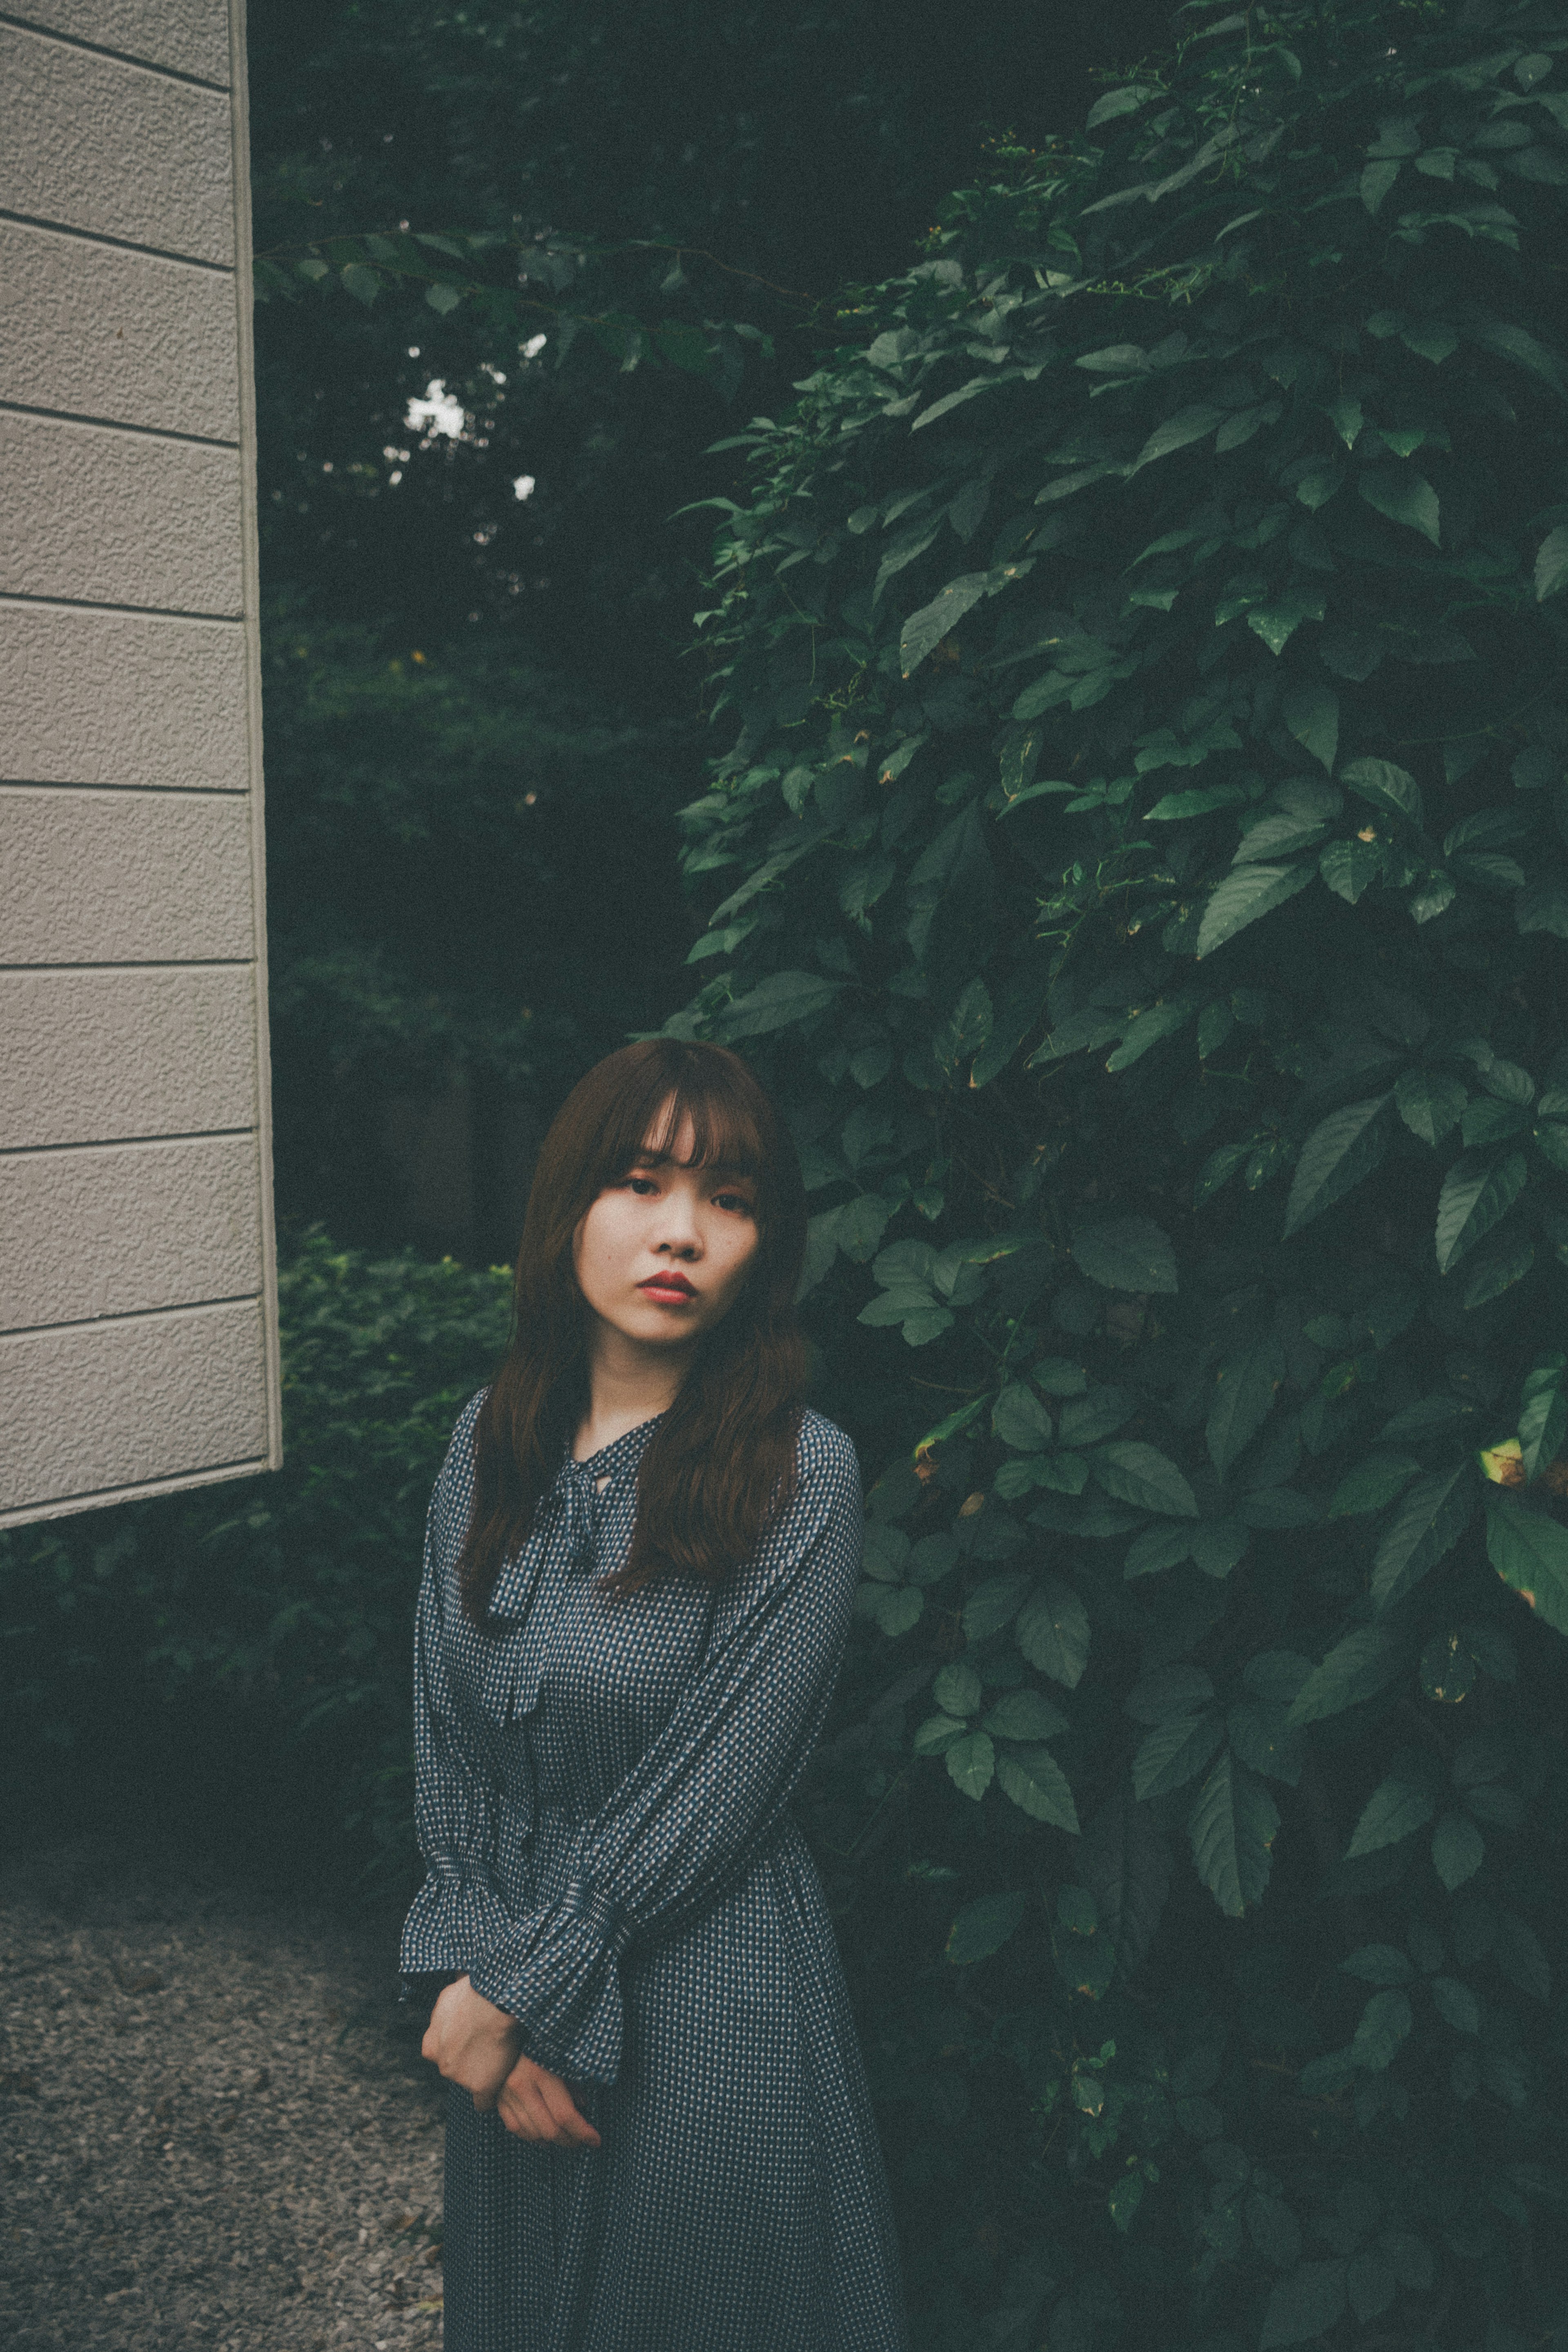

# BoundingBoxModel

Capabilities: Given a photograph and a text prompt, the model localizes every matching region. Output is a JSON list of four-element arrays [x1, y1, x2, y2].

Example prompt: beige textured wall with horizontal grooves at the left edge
[[0, 0, 280, 1527]]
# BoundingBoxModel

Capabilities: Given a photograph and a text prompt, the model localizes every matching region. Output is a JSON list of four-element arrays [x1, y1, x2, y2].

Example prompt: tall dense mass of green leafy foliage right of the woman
[[673, 0, 1568, 2352]]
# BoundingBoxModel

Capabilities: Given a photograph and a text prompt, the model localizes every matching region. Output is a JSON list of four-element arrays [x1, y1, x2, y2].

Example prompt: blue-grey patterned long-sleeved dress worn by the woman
[[402, 1397, 905, 2352]]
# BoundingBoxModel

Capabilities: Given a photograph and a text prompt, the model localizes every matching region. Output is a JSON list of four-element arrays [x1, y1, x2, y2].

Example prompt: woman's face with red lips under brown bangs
[[571, 1119, 760, 1348]]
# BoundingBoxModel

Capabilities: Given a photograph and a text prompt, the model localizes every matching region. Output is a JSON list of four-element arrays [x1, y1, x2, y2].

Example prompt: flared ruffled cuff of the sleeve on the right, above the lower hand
[[468, 1879, 630, 2084]]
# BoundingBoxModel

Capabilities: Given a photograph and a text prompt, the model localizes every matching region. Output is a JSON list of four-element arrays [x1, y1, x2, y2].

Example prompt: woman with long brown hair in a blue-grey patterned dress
[[402, 1039, 905, 2352]]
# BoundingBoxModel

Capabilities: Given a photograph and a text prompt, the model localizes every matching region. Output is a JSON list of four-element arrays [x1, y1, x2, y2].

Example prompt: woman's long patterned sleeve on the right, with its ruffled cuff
[[470, 1416, 860, 2082]]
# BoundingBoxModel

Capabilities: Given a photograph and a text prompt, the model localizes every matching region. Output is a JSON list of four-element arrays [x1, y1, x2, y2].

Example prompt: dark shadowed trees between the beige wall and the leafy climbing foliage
[[252, 0, 1168, 1261]]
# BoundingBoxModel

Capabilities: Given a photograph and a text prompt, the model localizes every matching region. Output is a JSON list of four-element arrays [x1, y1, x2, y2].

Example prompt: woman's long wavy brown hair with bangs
[[459, 1037, 806, 1632]]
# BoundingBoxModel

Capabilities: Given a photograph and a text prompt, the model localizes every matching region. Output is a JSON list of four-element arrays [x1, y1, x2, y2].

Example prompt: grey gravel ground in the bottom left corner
[[0, 1839, 442, 2352]]
